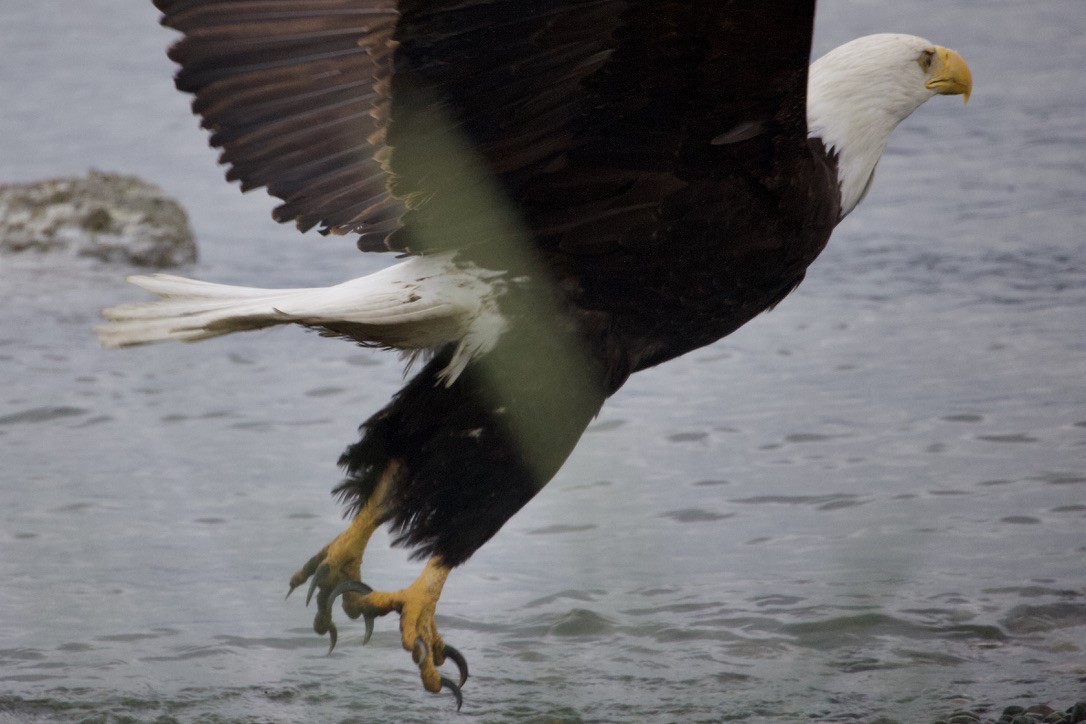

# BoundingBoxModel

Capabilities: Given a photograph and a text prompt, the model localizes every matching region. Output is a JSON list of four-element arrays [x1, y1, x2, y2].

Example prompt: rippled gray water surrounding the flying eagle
[[0, 0, 1086, 722]]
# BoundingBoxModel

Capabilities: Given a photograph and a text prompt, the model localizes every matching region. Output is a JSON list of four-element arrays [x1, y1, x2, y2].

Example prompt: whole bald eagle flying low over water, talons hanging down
[[97, 0, 972, 706]]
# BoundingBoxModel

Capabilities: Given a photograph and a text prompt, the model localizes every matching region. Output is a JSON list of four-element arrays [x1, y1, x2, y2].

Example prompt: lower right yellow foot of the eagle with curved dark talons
[[328, 556, 468, 710]]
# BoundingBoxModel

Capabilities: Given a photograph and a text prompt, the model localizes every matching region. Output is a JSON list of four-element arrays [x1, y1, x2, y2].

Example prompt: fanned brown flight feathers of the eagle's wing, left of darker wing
[[155, 0, 400, 233]]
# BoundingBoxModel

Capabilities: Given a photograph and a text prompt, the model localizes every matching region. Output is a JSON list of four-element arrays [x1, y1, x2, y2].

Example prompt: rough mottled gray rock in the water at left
[[0, 170, 197, 267]]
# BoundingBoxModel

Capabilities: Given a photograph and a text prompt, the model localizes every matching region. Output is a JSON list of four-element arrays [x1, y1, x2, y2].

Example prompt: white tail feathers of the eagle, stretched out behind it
[[94, 257, 505, 382]]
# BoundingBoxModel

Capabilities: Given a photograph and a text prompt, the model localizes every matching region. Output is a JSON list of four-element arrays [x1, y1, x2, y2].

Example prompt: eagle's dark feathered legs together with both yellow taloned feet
[[291, 335, 610, 704]]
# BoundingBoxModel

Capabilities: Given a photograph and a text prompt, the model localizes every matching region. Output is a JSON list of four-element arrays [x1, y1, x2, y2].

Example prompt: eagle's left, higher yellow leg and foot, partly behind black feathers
[[287, 462, 399, 652]]
